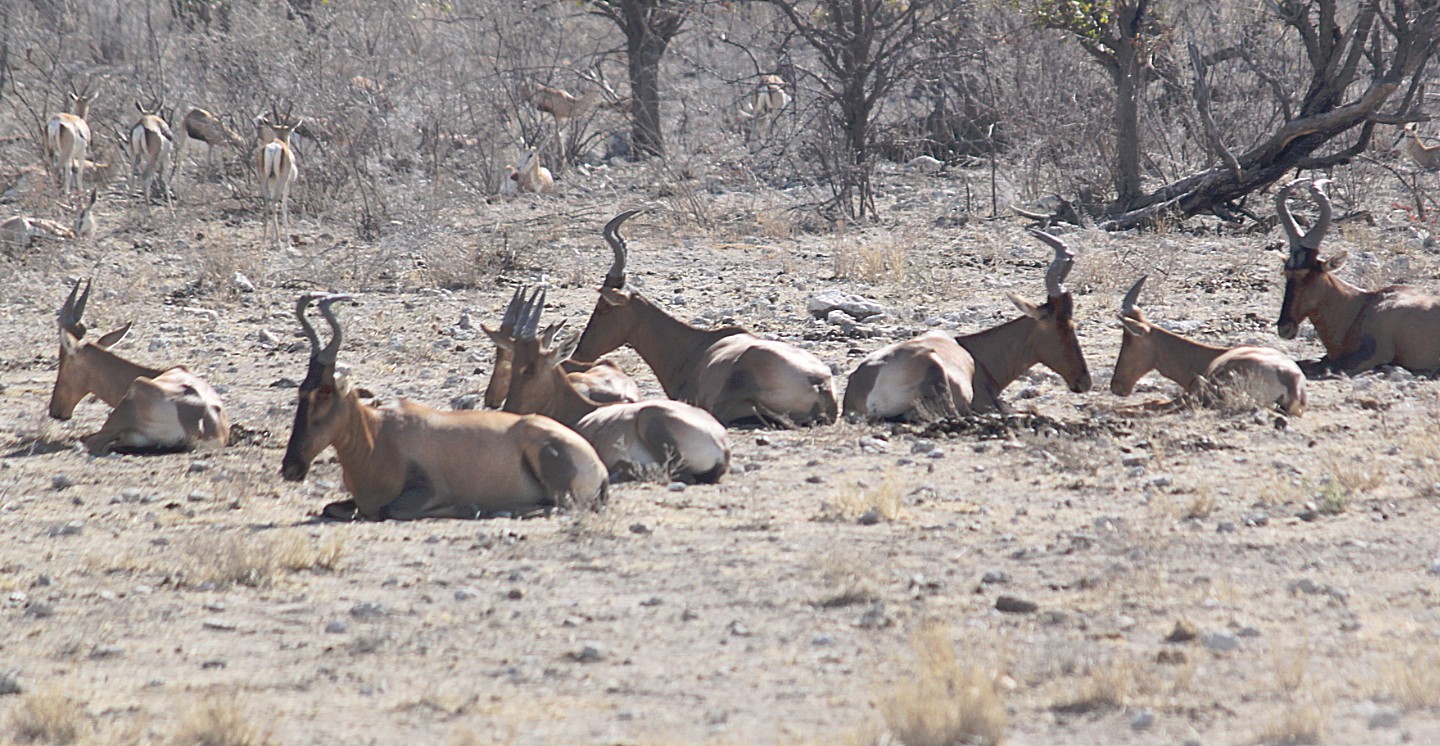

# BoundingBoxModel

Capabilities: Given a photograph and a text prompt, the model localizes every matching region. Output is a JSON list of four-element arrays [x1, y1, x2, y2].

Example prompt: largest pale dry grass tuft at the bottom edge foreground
[[880, 624, 1005, 746]]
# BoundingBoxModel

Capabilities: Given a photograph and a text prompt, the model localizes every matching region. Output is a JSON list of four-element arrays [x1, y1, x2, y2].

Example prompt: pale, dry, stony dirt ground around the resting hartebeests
[[0, 167, 1440, 746]]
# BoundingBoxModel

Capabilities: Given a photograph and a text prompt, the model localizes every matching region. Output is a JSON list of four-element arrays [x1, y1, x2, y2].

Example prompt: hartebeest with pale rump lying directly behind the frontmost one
[[485, 289, 730, 484]]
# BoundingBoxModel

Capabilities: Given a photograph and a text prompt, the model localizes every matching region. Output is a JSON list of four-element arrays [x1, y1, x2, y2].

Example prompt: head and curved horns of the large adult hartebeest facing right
[[1005, 229, 1090, 393]]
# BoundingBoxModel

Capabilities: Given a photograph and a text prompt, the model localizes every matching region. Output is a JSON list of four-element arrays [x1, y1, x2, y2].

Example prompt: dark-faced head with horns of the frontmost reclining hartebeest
[[281, 292, 354, 482]]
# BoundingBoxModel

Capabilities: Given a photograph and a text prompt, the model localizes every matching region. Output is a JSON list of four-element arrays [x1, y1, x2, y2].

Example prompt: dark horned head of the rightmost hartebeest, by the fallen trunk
[[1274, 179, 1345, 340]]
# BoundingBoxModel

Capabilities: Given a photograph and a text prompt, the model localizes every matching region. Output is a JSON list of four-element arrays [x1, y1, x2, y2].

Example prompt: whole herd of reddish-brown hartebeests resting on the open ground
[[30, 172, 1440, 520]]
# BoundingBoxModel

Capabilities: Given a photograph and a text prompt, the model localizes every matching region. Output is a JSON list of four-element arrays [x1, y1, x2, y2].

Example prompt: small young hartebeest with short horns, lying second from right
[[1110, 277, 1306, 416]]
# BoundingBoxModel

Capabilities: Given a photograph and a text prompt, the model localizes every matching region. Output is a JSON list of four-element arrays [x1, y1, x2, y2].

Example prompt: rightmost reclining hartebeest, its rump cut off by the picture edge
[[1274, 179, 1440, 376]]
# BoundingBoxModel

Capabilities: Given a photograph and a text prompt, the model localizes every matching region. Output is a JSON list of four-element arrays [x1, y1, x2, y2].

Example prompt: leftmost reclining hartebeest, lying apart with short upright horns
[[50, 281, 230, 455]]
